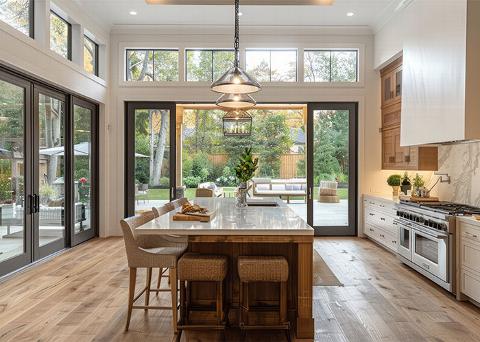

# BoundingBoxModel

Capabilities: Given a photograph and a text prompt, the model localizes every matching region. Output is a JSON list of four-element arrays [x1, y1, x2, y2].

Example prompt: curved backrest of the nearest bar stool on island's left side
[[120, 211, 155, 267]]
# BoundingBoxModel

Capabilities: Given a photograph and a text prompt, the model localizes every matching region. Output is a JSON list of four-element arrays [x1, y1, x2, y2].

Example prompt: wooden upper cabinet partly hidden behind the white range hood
[[381, 58, 438, 171]]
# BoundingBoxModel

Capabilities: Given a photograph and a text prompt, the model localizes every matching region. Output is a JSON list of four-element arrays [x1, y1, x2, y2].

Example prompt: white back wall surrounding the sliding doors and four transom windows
[[105, 26, 381, 235]]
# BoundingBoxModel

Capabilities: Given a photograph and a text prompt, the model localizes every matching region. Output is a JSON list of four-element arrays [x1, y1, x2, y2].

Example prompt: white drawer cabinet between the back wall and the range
[[363, 195, 399, 252]]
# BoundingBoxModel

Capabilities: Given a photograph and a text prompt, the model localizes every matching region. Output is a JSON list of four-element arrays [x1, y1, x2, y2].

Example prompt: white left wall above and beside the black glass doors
[[0, 0, 109, 235]]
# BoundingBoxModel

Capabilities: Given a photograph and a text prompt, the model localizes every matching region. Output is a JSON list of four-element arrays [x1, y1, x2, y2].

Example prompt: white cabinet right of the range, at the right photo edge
[[457, 218, 480, 303]]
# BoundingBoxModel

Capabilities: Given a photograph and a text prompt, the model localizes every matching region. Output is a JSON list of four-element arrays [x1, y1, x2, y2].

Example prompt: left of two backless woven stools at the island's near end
[[177, 253, 228, 332]]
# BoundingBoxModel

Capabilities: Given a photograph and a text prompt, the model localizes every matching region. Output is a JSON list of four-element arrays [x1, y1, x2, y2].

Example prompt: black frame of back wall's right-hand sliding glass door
[[307, 102, 358, 236]]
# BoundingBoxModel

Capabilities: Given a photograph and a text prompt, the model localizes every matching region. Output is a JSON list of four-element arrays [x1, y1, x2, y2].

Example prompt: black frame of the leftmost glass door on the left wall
[[0, 70, 33, 275]]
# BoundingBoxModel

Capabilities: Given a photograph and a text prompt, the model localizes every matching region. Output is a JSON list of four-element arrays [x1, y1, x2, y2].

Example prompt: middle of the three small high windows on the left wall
[[50, 11, 72, 60]]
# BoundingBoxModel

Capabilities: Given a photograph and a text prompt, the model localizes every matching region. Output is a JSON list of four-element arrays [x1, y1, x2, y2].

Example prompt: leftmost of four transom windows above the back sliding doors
[[126, 49, 178, 82]]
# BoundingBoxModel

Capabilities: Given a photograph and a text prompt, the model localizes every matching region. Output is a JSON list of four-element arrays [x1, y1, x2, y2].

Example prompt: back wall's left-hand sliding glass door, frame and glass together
[[125, 102, 176, 216]]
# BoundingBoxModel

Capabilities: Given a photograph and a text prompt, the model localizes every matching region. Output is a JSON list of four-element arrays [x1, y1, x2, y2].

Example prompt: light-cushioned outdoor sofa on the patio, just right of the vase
[[252, 178, 307, 203]]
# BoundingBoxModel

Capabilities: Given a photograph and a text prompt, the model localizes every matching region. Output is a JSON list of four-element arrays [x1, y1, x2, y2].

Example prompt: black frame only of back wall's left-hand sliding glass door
[[125, 101, 177, 217]]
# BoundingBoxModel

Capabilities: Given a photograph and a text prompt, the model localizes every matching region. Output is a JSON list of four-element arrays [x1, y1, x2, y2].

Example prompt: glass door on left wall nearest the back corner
[[71, 98, 97, 245]]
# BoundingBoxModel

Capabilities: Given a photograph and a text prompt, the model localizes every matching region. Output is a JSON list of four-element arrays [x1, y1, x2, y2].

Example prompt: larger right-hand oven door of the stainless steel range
[[411, 229, 448, 282]]
